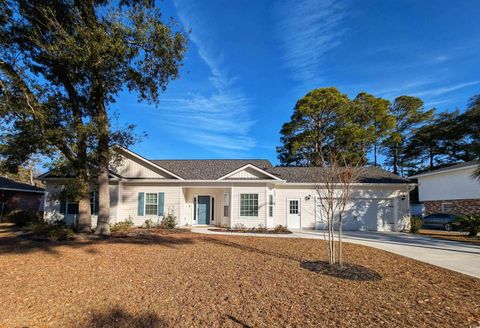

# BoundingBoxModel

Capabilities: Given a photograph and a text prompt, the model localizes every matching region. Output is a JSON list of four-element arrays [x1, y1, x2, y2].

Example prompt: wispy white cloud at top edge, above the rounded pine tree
[[276, 0, 347, 83]]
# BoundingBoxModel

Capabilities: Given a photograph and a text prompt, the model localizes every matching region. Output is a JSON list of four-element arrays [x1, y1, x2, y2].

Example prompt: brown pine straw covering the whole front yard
[[0, 231, 480, 328]]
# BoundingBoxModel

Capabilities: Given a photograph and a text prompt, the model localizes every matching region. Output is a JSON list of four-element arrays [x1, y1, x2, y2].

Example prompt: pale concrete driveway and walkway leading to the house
[[192, 228, 480, 278]]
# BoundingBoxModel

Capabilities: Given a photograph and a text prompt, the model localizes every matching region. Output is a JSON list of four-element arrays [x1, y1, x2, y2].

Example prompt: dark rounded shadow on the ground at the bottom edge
[[76, 307, 169, 328]]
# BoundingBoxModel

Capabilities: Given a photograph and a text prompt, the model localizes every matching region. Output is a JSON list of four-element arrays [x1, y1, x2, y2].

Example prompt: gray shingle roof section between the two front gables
[[151, 159, 272, 180]]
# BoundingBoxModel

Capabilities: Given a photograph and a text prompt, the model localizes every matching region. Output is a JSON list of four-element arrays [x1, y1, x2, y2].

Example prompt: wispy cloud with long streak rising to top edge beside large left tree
[[158, 0, 255, 156]]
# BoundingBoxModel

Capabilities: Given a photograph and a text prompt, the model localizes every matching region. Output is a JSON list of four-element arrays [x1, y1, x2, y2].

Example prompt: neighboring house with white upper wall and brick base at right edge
[[411, 160, 480, 215]]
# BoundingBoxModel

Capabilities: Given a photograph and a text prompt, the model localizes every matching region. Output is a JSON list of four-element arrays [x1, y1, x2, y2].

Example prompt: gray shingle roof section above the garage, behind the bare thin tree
[[268, 166, 410, 183]]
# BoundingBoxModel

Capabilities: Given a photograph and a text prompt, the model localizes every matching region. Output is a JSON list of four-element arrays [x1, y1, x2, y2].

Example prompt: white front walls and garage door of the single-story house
[[45, 176, 410, 231]]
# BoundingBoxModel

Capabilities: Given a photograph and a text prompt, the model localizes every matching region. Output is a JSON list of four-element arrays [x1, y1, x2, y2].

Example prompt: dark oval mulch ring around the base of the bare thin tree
[[300, 261, 382, 281]]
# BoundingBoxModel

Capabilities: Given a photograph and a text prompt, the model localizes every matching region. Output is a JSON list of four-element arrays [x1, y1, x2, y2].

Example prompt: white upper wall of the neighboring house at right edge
[[418, 167, 480, 202]]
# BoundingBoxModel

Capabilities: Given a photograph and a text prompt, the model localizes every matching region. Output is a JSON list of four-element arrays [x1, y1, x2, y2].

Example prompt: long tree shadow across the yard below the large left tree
[[0, 228, 195, 255]]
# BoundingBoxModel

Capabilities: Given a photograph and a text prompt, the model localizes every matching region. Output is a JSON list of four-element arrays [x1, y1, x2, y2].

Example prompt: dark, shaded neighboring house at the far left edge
[[0, 177, 45, 220]]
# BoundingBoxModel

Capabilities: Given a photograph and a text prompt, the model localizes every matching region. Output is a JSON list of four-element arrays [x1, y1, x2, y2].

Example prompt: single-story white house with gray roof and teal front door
[[39, 147, 413, 231]]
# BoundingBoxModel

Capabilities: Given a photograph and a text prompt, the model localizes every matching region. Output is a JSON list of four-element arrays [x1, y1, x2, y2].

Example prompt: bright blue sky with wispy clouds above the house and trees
[[114, 0, 480, 164]]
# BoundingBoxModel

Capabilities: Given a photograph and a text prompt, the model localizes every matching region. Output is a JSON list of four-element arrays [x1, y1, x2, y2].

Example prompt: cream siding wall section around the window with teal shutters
[[116, 183, 182, 226]]
